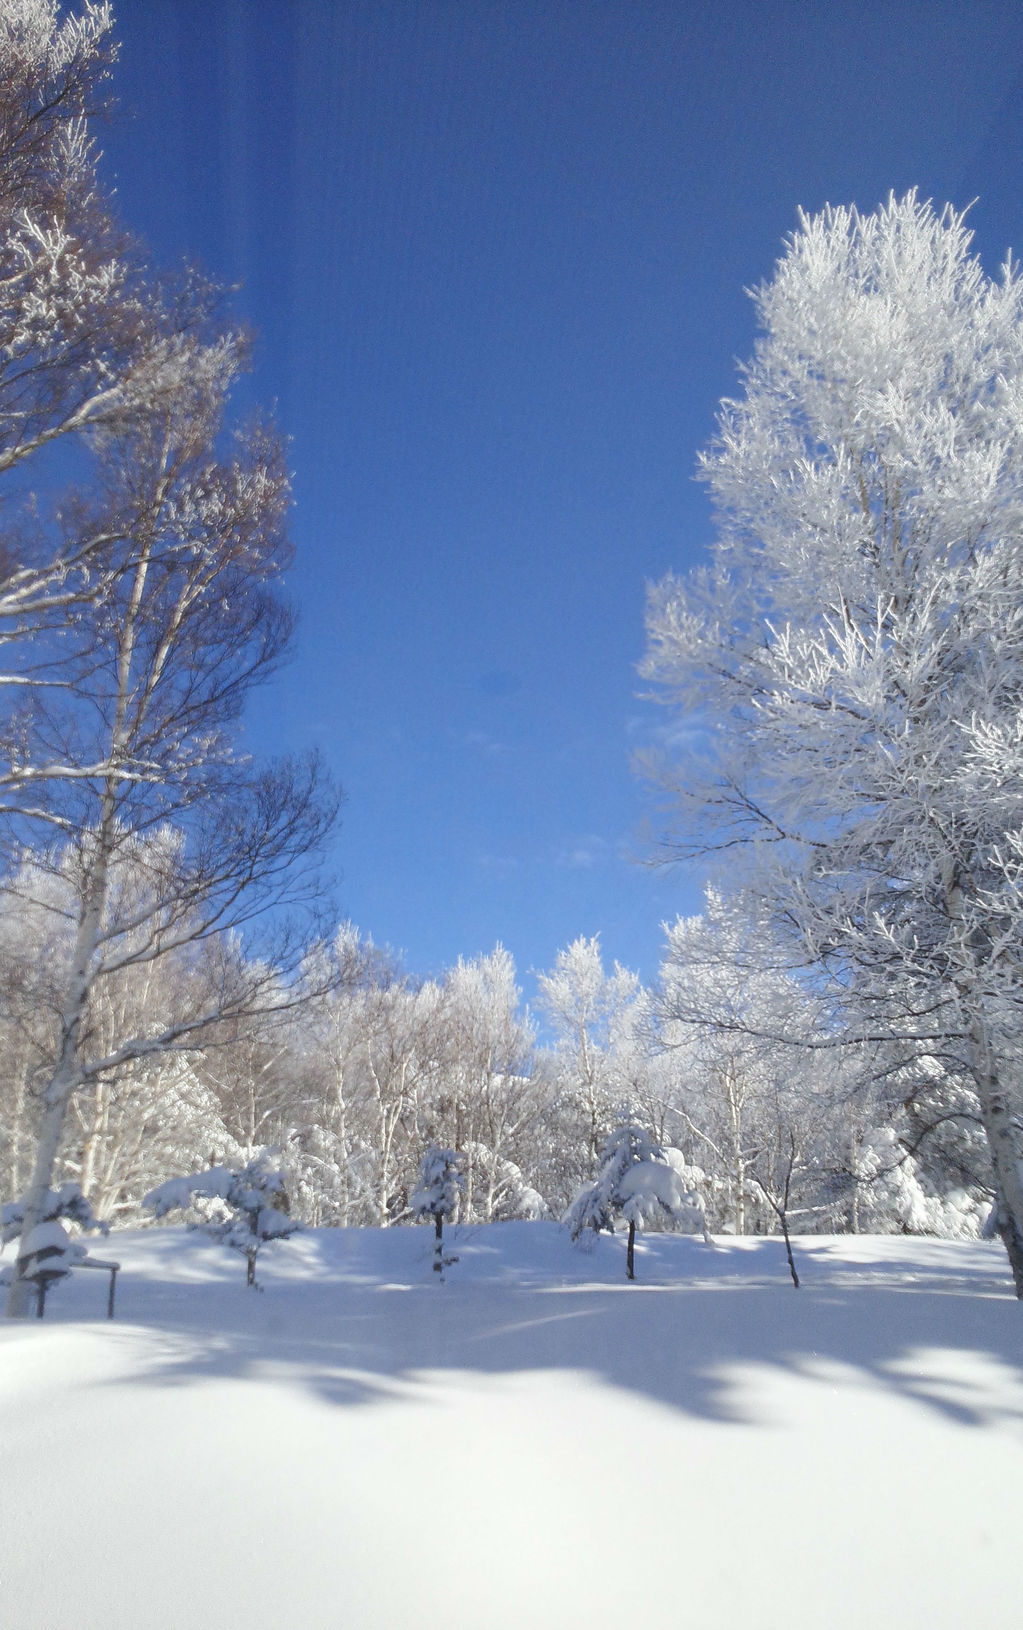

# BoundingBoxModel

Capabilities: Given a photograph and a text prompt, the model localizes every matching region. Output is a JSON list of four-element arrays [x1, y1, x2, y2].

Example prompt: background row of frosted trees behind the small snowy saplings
[[0, 854, 990, 1236]]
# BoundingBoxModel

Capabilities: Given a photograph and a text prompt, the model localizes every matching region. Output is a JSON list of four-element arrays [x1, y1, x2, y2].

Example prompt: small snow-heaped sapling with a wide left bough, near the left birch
[[142, 1149, 301, 1289]]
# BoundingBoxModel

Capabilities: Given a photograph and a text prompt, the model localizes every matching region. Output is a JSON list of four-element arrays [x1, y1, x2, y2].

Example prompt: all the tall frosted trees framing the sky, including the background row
[[0, 0, 1023, 1311]]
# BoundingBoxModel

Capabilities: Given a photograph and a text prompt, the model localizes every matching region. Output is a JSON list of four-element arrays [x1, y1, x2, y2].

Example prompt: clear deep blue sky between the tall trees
[[103, 0, 1023, 985]]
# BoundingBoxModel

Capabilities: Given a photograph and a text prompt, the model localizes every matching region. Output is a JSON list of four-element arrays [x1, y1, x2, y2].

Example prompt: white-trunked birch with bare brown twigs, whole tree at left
[[8, 341, 331, 1312]]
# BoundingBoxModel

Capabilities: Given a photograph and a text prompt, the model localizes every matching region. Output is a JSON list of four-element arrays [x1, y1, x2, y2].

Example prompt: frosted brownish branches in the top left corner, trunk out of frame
[[0, 0, 241, 694]]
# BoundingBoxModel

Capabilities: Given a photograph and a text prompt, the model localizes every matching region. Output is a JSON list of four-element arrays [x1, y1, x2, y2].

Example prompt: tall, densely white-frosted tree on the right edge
[[647, 194, 1023, 1296]]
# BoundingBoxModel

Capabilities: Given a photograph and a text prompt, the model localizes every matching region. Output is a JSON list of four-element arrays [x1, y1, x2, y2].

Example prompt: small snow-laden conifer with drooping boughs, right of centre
[[565, 1120, 709, 1280]]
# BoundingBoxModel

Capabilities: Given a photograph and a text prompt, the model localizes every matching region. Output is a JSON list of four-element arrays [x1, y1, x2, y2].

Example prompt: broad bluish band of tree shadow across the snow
[[74, 1237, 1023, 1426]]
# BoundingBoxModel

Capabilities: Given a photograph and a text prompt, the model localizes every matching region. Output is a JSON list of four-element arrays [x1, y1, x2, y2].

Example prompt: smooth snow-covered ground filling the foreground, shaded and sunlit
[[0, 1223, 1023, 1630]]
